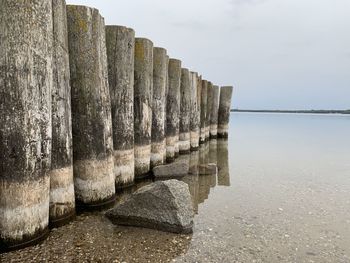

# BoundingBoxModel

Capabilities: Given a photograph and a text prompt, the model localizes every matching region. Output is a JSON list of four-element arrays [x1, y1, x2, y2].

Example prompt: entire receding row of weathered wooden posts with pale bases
[[0, 0, 232, 254]]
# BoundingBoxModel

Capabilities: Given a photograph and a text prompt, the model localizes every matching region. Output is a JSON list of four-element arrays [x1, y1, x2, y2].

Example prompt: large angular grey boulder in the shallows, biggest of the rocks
[[106, 180, 193, 234]]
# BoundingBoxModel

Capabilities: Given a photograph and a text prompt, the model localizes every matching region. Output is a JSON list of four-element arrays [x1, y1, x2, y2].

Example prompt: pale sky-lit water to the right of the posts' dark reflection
[[179, 113, 350, 262]]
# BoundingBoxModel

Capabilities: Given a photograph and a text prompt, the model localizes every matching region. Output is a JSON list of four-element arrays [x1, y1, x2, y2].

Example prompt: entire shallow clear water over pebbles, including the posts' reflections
[[0, 113, 350, 262]]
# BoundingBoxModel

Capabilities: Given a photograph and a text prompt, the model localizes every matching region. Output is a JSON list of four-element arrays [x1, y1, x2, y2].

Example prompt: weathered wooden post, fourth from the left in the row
[[106, 26, 135, 188]]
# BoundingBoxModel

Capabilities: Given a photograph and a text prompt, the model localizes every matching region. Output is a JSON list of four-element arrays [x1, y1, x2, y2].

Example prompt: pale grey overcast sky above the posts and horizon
[[67, 0, 350, 109]]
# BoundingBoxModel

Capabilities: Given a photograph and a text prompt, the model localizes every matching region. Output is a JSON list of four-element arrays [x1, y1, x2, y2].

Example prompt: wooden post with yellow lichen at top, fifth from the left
[[134, 38, 153, 178]]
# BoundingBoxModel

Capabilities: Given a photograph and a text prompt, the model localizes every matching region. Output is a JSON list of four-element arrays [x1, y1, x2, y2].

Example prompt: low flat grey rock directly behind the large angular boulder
[[152, 162, 190, 179]]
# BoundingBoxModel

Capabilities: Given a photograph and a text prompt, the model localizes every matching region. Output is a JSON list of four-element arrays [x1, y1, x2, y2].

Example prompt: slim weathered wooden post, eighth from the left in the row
[[179, 68, 191, 154]]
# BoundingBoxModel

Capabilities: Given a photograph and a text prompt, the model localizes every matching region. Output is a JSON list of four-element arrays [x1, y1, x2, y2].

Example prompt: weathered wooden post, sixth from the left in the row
[[151, 47, 168, 168]]
